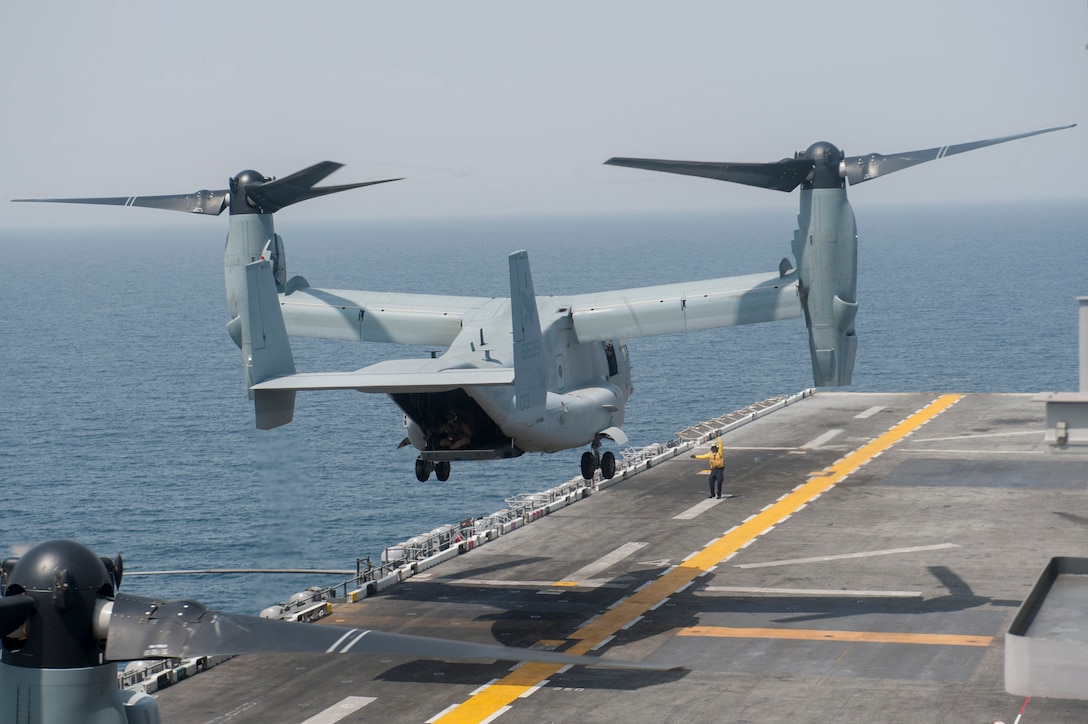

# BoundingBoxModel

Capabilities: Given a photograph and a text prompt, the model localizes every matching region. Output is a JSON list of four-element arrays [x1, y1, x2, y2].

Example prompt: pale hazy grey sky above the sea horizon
[[0, 0, 1088, 226]]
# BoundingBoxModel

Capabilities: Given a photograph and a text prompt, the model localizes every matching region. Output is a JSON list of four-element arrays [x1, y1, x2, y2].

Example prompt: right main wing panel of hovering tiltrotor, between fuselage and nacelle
[[564, 267, 801, 342]]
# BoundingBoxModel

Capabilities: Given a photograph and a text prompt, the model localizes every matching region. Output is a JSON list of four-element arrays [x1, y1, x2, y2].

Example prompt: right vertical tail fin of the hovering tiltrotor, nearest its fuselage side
[[510, 251, 547, 422]]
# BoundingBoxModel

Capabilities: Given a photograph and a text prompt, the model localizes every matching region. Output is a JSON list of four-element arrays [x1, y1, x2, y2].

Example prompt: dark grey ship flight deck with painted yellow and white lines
[[154, 392, 1088, 724]]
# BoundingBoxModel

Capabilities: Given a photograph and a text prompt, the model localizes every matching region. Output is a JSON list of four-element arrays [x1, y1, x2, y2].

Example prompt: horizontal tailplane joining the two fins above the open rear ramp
[[252, 359, 514, 394]]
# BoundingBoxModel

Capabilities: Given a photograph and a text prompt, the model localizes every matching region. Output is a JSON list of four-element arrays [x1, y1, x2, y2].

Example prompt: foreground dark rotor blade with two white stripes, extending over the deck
[[106, 593, 670, 671]]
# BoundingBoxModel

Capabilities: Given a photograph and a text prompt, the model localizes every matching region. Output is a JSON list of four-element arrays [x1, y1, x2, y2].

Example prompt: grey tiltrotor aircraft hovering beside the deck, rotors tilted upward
[[18, 125, 1072, 481]]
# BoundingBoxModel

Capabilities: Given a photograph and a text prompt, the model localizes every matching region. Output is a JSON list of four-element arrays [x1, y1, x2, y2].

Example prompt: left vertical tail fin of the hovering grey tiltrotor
[[240, 259, 295, 430]]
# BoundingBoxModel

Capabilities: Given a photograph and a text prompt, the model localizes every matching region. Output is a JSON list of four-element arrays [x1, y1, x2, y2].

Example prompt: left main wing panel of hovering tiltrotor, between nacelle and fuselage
[[280, 282, 493, 346]]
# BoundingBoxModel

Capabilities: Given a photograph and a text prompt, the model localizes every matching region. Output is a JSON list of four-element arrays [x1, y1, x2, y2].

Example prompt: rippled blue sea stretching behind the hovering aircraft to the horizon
[[0, 199, 1088, 613]]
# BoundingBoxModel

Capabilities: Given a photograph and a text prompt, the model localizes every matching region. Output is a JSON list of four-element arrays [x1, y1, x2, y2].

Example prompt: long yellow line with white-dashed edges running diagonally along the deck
[[431, 394, 963, 724]]
